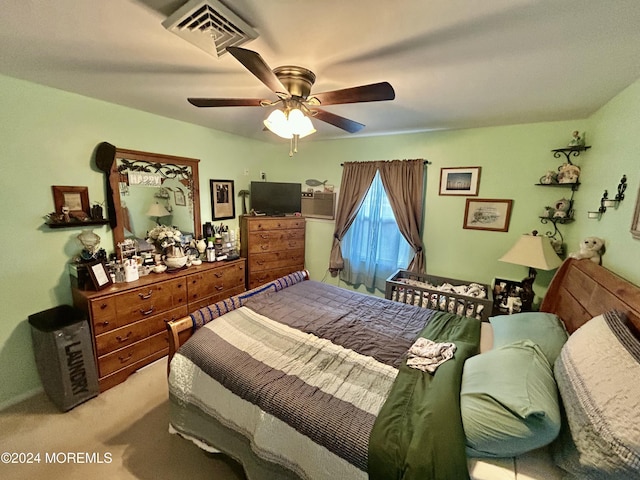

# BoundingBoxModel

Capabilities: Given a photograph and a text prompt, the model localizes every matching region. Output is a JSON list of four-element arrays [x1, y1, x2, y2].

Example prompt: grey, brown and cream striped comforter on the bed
[[169, 281, 434, 478]]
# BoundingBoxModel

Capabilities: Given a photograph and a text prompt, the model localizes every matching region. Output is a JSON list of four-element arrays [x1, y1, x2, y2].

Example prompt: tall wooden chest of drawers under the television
[[240, 215, 305, 289]]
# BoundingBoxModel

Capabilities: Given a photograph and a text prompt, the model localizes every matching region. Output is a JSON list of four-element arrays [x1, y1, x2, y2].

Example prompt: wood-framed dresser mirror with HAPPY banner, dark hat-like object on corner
[[96, 142, 202, 255]]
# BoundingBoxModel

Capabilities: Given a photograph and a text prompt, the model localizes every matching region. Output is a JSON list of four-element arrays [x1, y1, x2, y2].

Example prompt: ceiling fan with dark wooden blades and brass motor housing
[[187, 47, 395, 133]]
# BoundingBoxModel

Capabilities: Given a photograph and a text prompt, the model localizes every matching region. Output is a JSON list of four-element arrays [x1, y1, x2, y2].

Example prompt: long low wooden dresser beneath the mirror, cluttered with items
[[72, 258, 246, 392]]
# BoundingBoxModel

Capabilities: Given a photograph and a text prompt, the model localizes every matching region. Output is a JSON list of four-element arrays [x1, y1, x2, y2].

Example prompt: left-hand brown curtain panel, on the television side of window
[[329, 162, 378, 277]]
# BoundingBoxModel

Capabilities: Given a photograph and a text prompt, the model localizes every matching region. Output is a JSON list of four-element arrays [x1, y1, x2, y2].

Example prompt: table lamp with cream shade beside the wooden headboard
[[499, 230, 562, 312]]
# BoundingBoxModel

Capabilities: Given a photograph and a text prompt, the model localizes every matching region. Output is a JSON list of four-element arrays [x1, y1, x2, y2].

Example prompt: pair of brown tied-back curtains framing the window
[[329, 160, 425, 276]]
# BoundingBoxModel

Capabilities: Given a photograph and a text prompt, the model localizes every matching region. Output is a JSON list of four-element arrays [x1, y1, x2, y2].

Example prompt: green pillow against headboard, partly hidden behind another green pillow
[[489, 312, 569, 368]]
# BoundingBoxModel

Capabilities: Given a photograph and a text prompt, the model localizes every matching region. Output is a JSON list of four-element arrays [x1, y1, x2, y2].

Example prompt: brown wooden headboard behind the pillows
[[540, 258, 640, 338]]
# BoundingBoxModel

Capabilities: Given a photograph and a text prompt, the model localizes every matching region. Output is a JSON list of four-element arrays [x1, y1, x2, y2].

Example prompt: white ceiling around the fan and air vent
[[0, 0, 640, 141]]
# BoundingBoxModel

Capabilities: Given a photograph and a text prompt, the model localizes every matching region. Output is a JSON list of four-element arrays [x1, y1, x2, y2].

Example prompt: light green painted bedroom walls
[[0, 76, 640, 408]]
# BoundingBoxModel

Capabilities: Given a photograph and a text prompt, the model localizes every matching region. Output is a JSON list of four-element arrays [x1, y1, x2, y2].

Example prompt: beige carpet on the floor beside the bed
[[0, 359, 245, 480]]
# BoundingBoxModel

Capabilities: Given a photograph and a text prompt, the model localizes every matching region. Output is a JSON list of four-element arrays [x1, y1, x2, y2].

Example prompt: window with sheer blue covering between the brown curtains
[[340, 173, 413, 291]]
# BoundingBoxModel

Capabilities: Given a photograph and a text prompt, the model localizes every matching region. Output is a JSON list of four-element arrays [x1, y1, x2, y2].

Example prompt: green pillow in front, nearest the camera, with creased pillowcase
[[460, 340, 560, 457]]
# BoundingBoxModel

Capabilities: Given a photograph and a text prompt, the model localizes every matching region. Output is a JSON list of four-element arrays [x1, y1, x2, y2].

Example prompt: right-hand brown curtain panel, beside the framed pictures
[[379, 160, 425, 273]]
